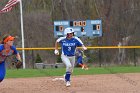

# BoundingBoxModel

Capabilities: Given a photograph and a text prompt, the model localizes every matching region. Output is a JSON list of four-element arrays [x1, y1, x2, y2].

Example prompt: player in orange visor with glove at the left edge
[[0, 35, 22, 82]]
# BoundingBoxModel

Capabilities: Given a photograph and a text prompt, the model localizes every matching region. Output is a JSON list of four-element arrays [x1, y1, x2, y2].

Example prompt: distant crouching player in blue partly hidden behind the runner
[[76, 49, 88, 70]]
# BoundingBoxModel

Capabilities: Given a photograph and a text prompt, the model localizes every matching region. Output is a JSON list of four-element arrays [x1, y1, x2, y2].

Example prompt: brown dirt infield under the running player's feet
[[0, 73, 140, 93]]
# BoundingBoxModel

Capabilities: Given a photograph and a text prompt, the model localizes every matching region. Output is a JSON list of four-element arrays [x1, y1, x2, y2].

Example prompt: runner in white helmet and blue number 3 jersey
[[54, 28, 87, 87]]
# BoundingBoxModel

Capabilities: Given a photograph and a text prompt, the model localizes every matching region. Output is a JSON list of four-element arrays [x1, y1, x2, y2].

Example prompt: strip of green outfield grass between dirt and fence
[[6, 67, 140, 78]]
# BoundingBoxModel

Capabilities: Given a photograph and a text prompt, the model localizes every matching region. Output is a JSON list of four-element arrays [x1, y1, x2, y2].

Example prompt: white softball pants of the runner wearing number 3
[[61, 54, 75, 73]]
